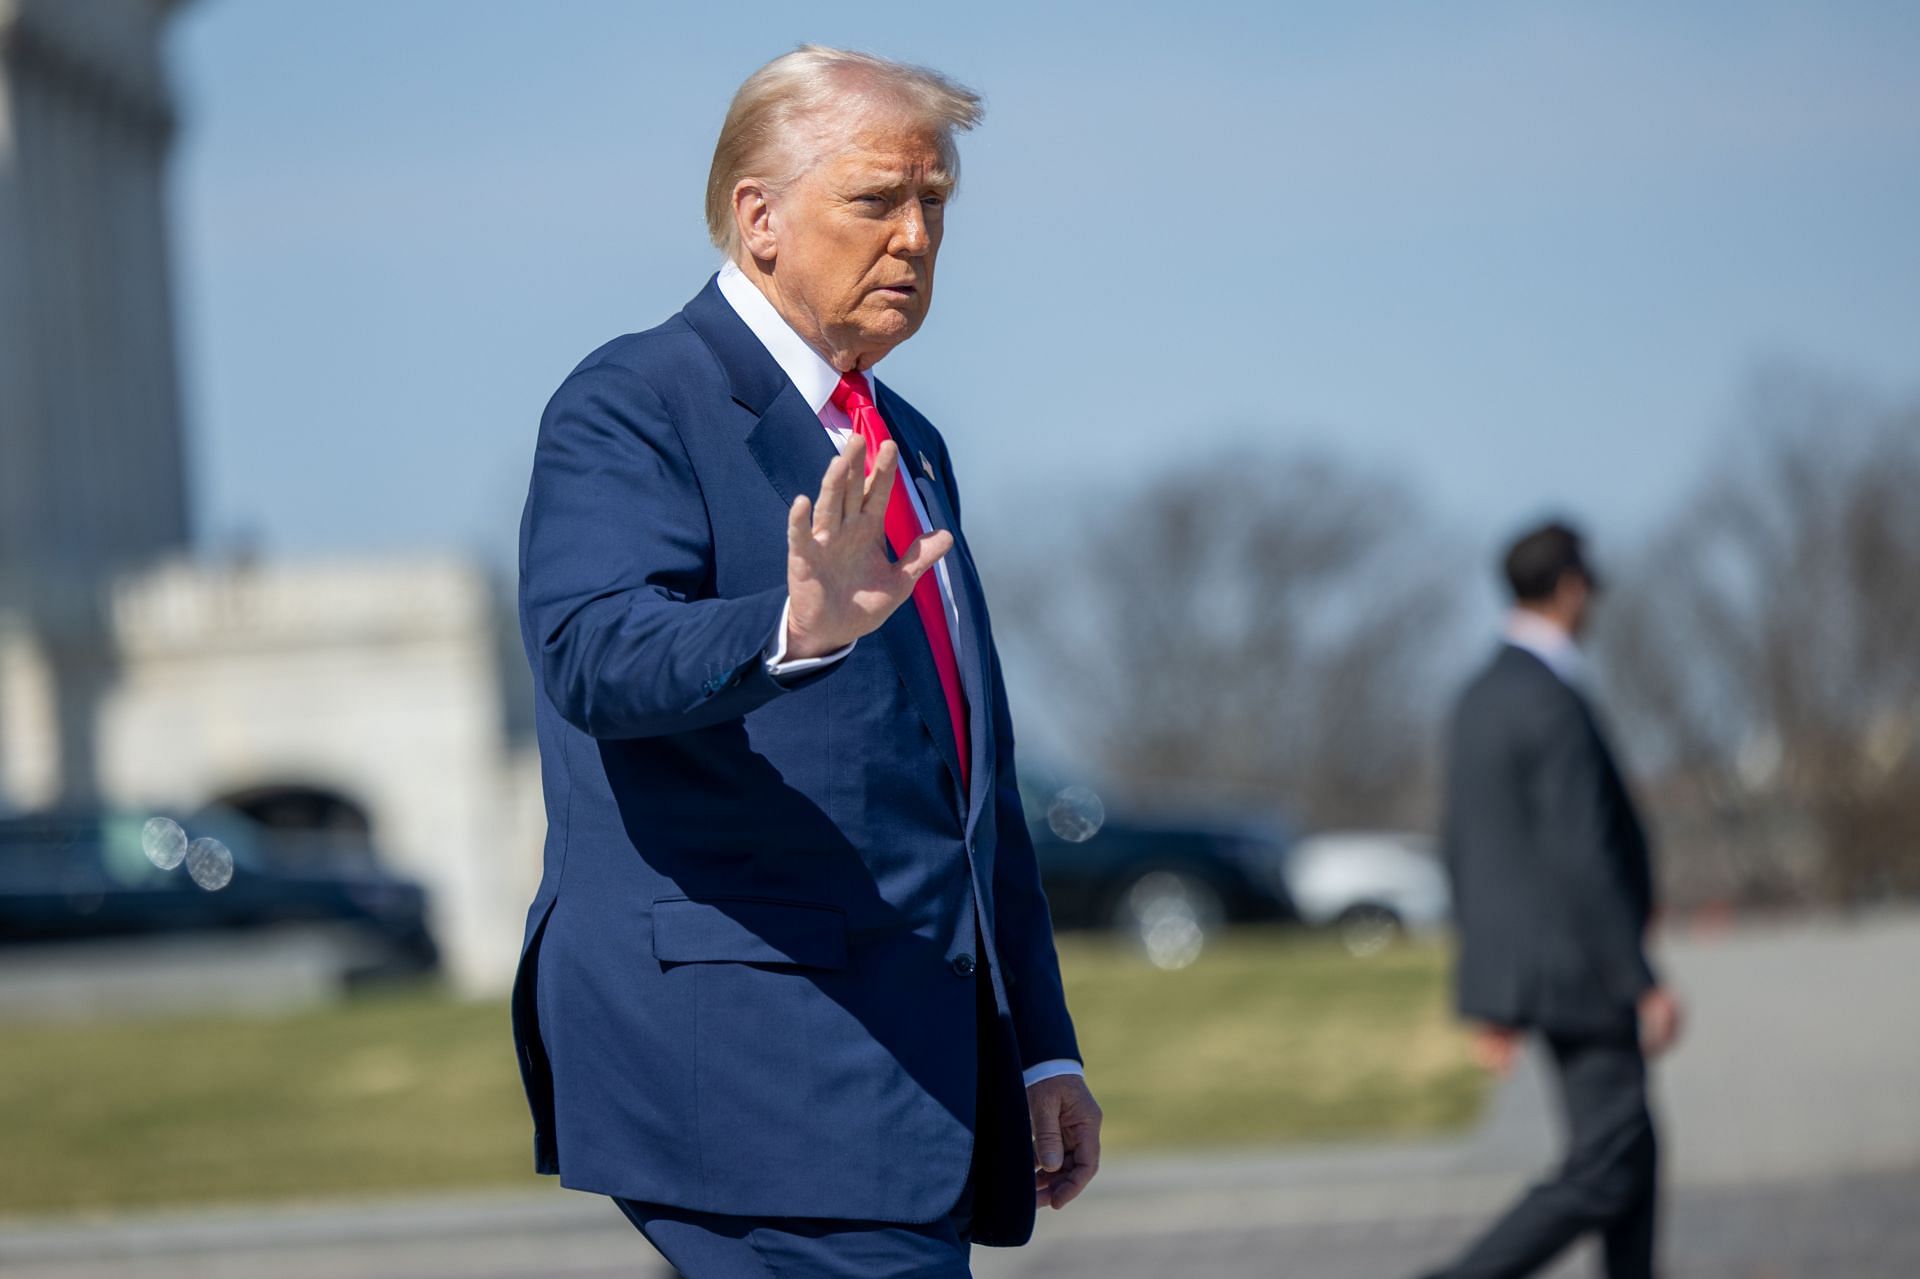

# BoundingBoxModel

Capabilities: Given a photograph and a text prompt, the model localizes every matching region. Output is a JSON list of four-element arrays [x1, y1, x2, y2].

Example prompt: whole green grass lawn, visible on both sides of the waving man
[[0, 929, 1482, 1216]]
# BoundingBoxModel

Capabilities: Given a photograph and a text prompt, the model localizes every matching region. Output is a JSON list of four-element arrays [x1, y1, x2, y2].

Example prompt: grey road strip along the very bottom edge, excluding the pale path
[[0, 1170, 1920, 1279]]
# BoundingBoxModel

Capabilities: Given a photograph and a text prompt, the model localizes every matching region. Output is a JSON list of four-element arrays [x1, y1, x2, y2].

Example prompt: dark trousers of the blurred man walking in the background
[[1436, 1026, 1657, 1279]]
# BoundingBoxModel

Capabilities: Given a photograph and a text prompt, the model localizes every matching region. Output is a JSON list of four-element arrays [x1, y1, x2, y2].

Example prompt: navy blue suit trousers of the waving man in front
[[614, 941, 1033, 1279]]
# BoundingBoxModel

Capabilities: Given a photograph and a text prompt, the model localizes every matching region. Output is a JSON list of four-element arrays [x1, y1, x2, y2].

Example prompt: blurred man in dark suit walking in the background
[[1440, 524, 1680, 1279]]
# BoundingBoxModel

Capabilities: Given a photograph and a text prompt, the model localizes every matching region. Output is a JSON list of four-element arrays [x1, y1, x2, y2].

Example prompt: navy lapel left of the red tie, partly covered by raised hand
[[682, 280, 966, 805]]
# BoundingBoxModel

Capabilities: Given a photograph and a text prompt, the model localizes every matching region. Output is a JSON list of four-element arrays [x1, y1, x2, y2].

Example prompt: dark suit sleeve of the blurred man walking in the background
[[1534, 709, 1655, 1004]]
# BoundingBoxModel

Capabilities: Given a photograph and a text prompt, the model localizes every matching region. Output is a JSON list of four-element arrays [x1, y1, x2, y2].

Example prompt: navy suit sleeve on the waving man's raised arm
[[520, 363, 831, 737]]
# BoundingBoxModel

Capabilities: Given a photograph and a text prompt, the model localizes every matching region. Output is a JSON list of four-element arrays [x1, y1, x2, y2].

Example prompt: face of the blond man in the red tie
[[756, 117, 952, 373]]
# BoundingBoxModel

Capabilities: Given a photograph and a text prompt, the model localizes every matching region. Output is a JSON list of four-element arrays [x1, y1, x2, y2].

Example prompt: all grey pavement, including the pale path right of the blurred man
[[0, 914, 1920, 1279]]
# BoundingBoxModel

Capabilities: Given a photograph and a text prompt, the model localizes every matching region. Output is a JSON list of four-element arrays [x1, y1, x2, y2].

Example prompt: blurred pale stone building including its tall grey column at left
[[0, 0, 543, 991]]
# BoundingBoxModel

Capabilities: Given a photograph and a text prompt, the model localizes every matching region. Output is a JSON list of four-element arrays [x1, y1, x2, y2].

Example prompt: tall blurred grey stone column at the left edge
[[0, 0, 188, 801]]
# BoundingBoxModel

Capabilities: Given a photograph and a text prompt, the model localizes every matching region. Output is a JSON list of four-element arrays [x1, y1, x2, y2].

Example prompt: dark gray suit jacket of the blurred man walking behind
[[1442, 645, 1655, 1033]]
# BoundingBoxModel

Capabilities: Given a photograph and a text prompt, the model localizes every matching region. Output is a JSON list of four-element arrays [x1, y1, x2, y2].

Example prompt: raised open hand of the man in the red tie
[[787, 434, 954, 659]]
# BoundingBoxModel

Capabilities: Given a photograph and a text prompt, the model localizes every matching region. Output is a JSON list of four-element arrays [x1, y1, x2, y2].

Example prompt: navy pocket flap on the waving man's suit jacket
[[653, 897, 847, 968]]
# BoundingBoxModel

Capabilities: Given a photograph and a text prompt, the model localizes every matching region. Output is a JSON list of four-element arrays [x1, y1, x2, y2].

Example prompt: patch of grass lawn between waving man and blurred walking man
[[1062, 929, 1484, 1150]]
